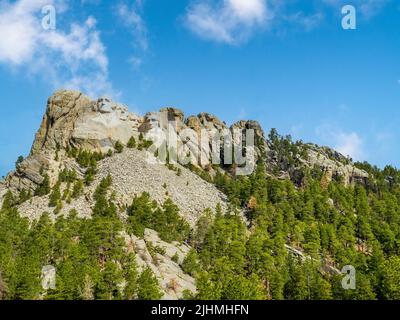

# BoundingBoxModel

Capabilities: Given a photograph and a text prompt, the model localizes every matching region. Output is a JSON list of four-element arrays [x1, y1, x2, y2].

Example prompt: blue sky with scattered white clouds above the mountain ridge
[[0, 0, 400, 175]]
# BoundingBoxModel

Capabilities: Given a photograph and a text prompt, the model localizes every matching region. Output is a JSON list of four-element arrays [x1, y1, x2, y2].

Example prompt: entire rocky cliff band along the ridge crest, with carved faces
[[0, 91, 368, 196]]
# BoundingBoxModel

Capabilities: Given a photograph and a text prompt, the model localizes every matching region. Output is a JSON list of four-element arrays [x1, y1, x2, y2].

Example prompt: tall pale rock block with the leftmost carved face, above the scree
[[31, 91, 142, 155]]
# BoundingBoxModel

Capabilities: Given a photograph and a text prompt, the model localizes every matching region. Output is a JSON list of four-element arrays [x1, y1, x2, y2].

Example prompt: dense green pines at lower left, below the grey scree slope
[[0, 177, 162, 299]]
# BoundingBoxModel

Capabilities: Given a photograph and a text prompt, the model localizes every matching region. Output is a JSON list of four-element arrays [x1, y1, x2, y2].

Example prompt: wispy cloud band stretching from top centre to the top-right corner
[[185, 0, 390, 45]]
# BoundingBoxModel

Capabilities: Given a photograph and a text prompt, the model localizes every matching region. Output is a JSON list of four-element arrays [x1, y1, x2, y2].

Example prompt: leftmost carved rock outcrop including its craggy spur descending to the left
[[5, 90, 142, 191]]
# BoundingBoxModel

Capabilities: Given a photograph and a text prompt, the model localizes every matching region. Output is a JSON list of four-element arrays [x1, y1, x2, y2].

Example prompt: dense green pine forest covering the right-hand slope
[[185, 131, 400, 299]]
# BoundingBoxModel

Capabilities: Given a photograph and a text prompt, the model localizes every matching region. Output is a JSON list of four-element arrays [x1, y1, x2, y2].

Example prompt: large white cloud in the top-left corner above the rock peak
[[0, 0, 114, 96]]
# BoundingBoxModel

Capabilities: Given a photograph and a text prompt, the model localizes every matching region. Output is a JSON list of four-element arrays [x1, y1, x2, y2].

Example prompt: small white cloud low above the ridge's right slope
[[315, 125, 366, 161]]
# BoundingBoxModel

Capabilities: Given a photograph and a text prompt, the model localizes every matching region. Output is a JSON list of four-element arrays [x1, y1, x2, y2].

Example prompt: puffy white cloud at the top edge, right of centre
[[185, 0, 272, 44]]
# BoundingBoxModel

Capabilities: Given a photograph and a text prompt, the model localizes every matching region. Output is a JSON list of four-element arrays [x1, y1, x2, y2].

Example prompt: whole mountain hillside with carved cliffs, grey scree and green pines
[[0, 91, 400, 299]]
